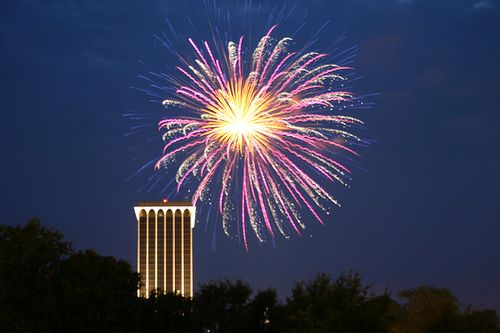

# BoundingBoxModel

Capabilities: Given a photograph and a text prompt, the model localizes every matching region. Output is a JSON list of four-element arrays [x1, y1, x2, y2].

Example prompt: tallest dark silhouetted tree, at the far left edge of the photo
[[0, 219, 71, 332]]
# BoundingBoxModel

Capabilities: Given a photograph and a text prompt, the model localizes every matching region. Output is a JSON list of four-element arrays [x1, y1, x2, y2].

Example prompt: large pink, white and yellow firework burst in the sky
[[156, 26, 363, 249]]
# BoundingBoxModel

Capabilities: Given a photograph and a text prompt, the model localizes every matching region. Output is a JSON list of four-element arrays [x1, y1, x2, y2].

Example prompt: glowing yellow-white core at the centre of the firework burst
[[203, 80, 284, 152]]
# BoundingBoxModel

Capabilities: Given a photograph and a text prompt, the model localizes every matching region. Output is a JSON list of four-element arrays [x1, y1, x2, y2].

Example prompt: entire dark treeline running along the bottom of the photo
[[0, 220, 500, 333]]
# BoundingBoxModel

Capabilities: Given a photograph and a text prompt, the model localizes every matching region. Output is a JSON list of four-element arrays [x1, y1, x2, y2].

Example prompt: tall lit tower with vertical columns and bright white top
[[134, 200, 196, 297]]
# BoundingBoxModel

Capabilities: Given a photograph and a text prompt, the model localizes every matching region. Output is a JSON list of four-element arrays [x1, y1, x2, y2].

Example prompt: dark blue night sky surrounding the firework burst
[[0, 0, 500, 311]]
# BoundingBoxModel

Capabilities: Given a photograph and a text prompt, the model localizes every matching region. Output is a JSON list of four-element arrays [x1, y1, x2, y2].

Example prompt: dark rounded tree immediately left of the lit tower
[[54, 250, 139, 332]]
